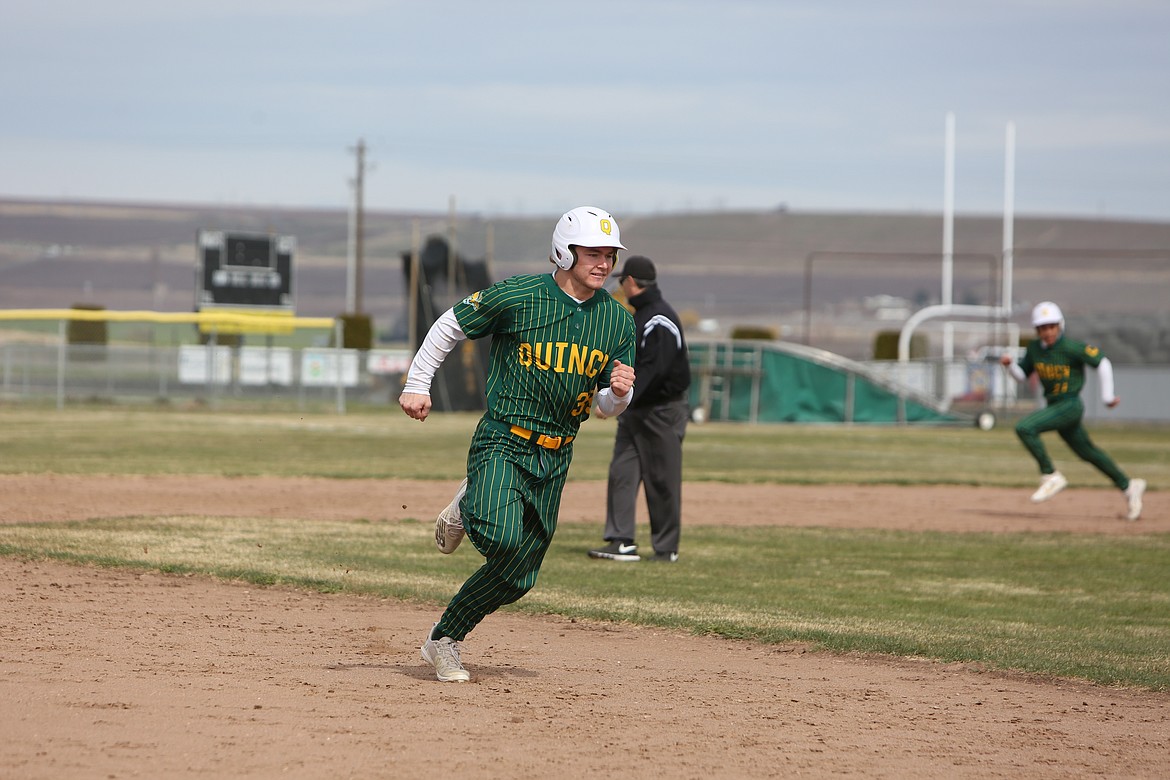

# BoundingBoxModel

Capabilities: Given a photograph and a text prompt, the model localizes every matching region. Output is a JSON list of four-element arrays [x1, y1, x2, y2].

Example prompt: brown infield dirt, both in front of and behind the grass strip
[[0, 476, 1170, 780]]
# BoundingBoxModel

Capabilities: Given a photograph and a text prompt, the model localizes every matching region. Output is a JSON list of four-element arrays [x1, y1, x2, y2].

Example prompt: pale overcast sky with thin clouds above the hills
[[0, 0, 1170, 221]]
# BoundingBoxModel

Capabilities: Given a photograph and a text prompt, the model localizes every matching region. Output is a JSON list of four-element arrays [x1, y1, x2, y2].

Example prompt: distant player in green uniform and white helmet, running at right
[[1000, 301, 1145, 520]]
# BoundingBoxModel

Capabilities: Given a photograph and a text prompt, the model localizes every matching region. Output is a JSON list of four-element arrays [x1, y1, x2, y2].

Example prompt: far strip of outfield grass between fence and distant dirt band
[[0, 406, 1170, 490]]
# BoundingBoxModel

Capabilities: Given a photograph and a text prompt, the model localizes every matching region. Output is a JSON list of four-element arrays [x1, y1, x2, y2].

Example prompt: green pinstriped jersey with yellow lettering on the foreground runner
[[454, 274, 635, 436]]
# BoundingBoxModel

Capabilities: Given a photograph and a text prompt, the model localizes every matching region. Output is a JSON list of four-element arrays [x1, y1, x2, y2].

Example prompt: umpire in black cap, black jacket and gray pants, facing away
[[589, 255, 690, 562]]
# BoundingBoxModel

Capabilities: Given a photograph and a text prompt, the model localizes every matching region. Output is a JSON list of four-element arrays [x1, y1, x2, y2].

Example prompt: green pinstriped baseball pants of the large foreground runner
[[438, 417, 572, 641]]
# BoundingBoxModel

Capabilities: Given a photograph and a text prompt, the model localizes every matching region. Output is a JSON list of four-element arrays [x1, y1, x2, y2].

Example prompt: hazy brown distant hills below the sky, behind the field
[[0, 199, 1170, 361]]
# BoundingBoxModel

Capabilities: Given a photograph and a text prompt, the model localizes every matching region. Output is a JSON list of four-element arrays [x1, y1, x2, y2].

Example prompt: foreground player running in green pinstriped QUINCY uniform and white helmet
[[399, 206, 635, 682]]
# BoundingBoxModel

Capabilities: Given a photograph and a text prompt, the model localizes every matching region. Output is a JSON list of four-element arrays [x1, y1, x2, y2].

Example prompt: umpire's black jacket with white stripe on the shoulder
[[629, 287, 690, 408]]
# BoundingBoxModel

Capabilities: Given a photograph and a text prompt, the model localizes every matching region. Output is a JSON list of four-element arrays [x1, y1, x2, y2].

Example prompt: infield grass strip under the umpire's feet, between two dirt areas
[[0, 517, 1170, 690]]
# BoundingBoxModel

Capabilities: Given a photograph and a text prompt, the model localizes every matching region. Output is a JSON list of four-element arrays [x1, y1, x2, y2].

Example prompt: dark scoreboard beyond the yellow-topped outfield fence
[[195, 230, 296, 313]]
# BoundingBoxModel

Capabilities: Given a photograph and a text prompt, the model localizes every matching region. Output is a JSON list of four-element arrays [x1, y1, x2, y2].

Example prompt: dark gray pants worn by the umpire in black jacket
[[605, 399, 689, 552]]
